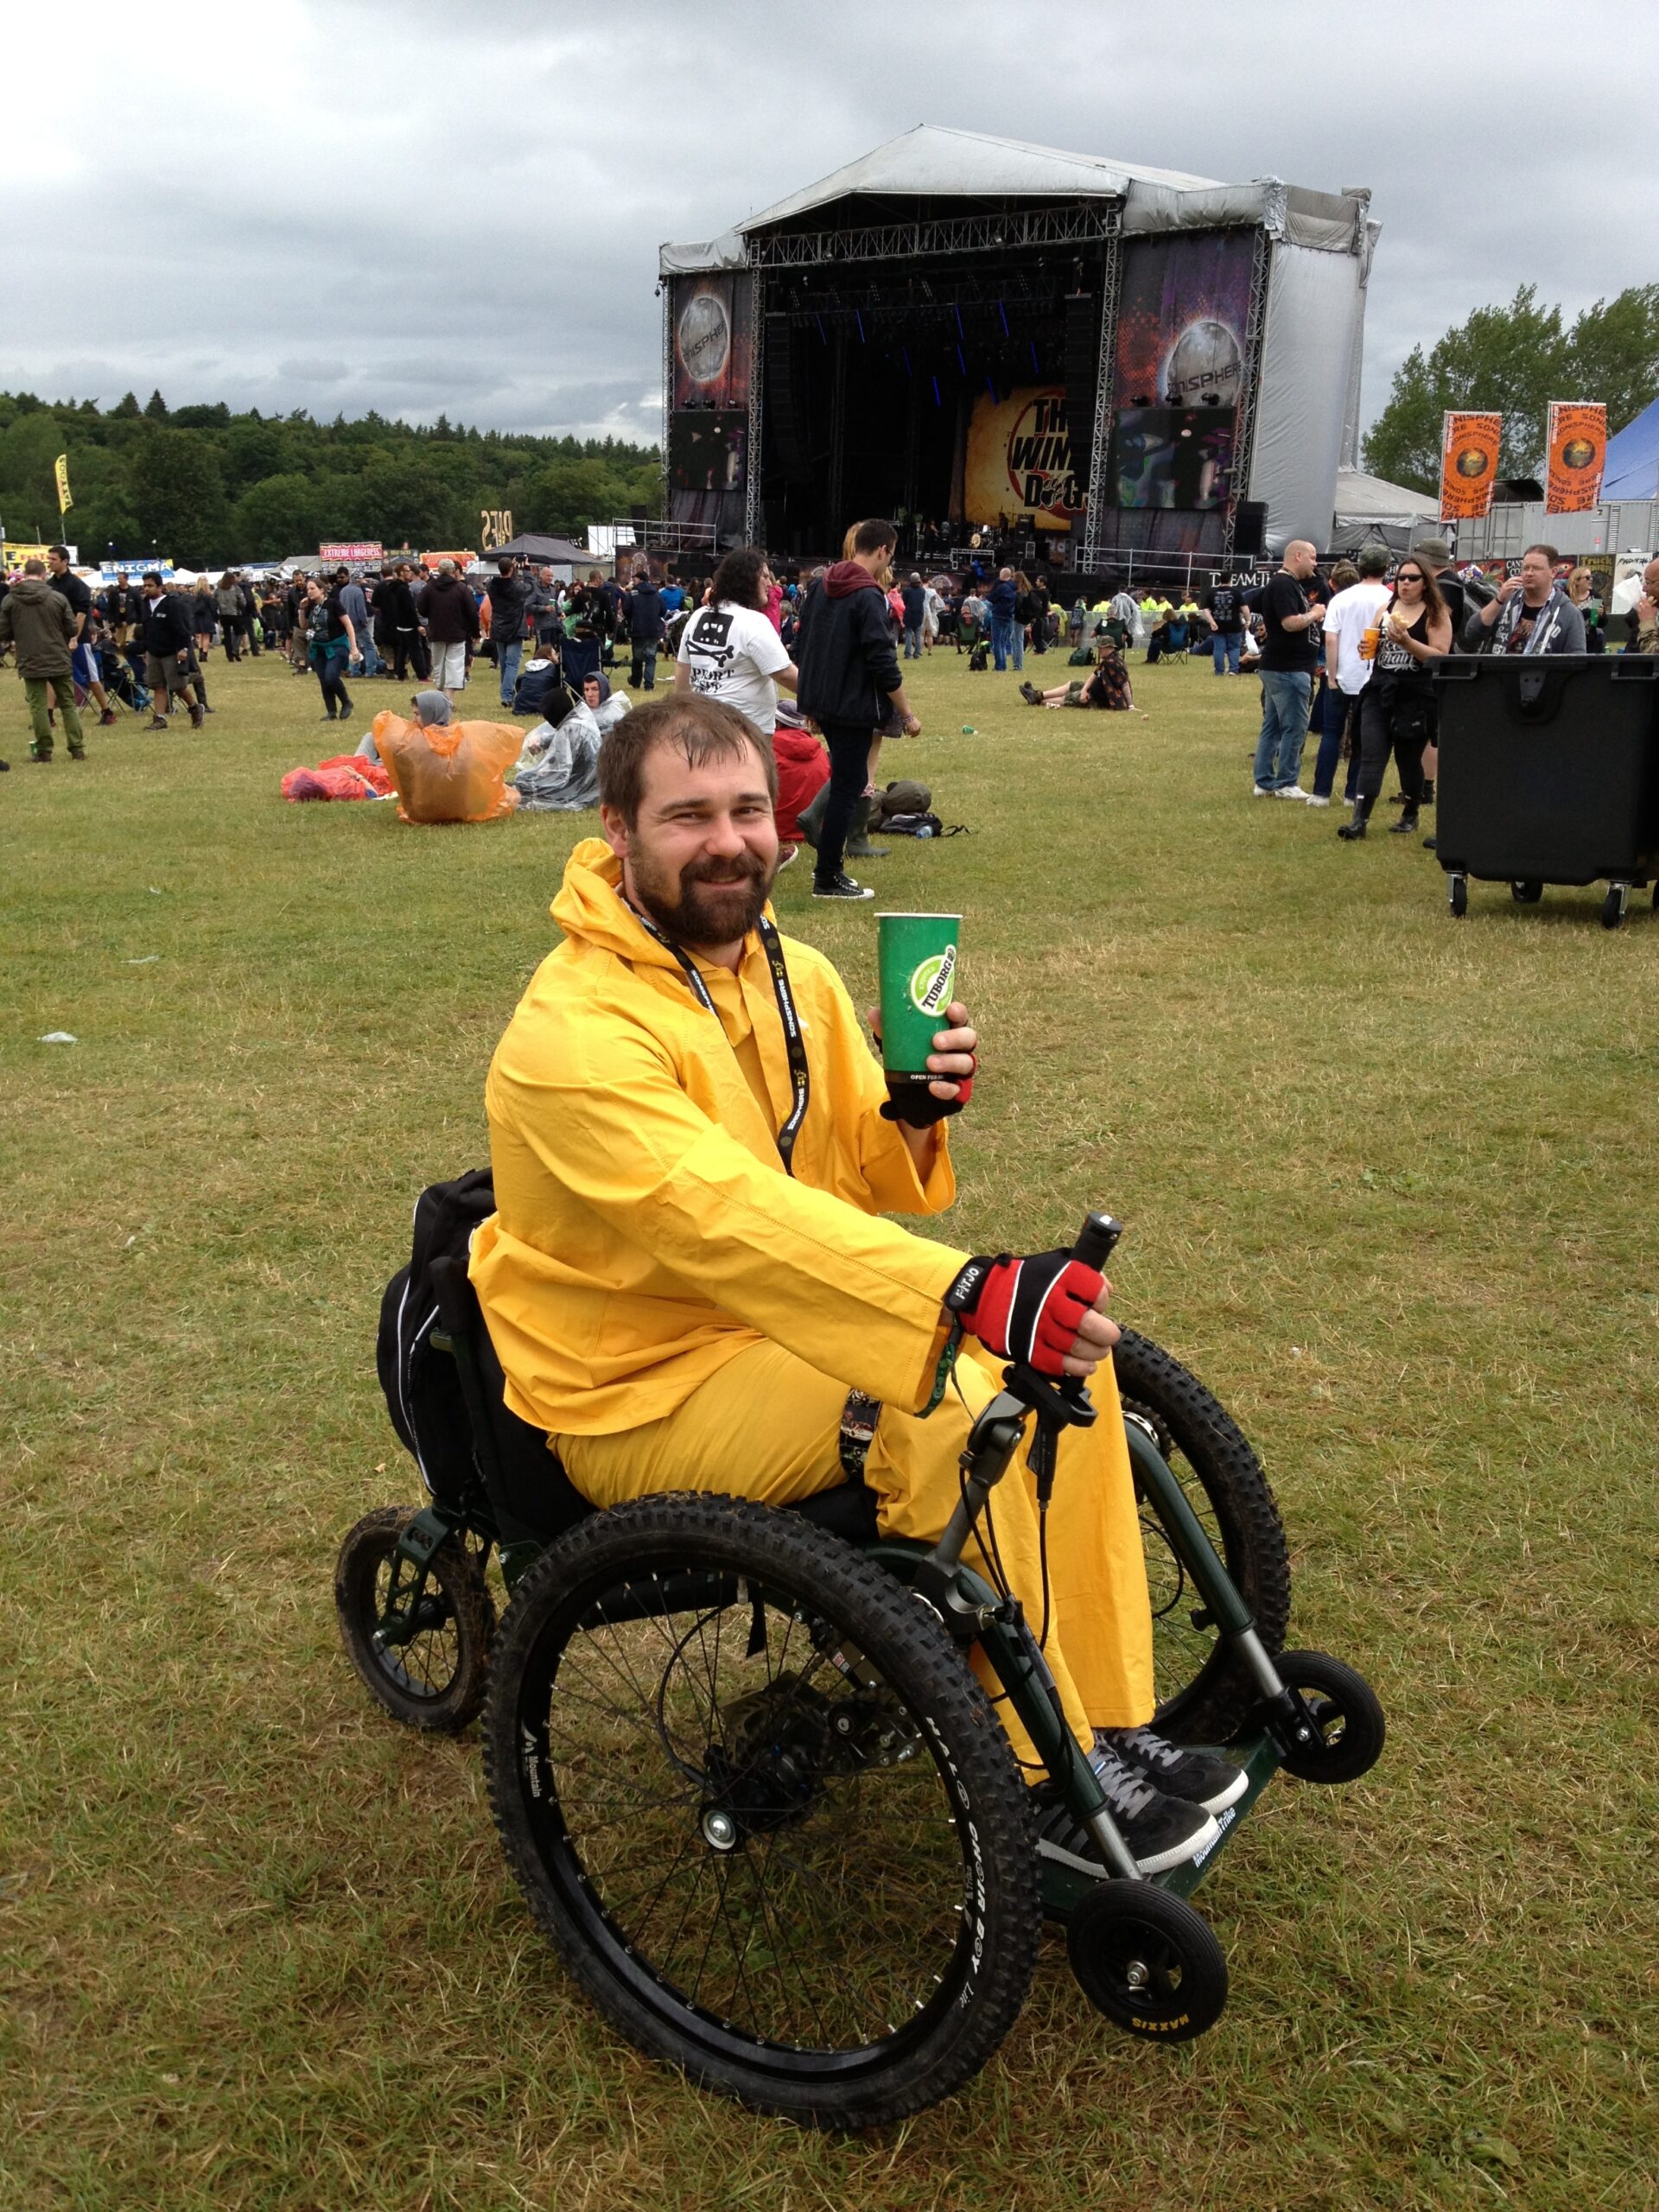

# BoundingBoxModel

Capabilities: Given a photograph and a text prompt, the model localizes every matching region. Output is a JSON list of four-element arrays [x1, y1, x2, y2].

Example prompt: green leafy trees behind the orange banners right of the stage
[[1365, 285, 1659, 493]]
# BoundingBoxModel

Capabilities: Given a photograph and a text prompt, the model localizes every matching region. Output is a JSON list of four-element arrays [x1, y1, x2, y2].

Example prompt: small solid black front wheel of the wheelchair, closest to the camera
[[1066, 1883, 1228, 2044]]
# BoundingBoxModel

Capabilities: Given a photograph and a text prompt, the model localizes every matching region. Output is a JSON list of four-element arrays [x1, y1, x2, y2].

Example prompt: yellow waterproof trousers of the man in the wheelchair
[[556, 1343, 1153, 1761]]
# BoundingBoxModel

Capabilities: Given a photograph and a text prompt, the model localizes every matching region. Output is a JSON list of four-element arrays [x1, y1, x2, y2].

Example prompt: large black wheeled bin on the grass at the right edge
[[1433, 652, 1659, 929]]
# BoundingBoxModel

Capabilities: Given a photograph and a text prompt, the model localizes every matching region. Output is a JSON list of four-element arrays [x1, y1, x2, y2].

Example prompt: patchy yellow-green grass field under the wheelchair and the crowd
[[0, 632, 1659, 2212]]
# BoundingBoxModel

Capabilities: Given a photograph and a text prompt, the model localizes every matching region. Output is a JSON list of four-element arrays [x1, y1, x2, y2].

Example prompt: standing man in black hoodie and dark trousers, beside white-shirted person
[[794, 522, 923, 898]]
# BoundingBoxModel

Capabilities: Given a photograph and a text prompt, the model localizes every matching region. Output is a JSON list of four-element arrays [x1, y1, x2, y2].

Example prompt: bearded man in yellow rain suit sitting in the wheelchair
[[471, 692, 1245, 1878]]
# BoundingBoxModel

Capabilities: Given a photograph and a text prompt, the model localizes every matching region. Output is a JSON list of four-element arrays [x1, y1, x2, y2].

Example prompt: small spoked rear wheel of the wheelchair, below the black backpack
[[334, 1506, 495, 1734]]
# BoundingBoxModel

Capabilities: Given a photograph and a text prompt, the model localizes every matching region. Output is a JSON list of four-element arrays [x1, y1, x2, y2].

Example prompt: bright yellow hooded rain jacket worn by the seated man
[[471, 838, 967, 1435]]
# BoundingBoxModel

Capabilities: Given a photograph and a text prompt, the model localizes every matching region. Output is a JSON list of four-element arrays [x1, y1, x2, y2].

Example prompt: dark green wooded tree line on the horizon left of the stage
[[0, 391, 661, 569]]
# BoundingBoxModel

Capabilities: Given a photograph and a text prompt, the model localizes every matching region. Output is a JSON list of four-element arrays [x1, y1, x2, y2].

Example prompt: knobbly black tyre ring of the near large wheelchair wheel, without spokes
[[485, 1493, 1042, 2128]]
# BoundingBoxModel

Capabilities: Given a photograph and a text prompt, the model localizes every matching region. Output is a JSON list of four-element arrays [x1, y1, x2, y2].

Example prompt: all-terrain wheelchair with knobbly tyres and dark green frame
[[336, 1214, 1382, 2126]]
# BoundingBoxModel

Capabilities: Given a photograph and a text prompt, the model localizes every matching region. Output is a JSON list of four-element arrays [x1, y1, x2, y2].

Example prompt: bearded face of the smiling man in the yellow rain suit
[[601, 743, 779, 947]]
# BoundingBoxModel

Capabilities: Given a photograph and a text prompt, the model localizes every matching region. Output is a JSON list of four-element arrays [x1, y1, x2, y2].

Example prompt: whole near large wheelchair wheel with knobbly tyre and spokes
[[485, 1493, 1042, 2128]]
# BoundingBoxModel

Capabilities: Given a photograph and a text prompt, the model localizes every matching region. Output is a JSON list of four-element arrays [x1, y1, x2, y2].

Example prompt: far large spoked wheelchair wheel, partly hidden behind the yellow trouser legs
[[1113, 1330, 1289, 1743]]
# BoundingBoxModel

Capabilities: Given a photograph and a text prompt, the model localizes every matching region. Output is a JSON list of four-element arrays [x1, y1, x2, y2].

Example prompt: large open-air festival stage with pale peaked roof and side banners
[[659, 126, 1378, 566]]
